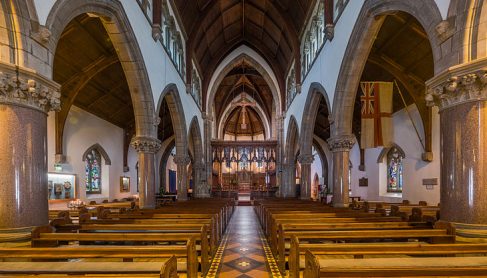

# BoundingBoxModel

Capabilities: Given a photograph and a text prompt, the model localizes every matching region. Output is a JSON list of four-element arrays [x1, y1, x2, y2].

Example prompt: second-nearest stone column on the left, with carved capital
[[130, 136, 161, 208]]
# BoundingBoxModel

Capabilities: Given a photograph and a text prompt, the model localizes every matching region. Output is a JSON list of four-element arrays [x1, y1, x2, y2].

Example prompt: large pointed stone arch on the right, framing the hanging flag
[[331, 0, 442, 136]]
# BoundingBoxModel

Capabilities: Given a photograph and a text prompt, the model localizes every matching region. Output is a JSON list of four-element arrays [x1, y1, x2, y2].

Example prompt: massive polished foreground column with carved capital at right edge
[[426, 59, 487, 224]]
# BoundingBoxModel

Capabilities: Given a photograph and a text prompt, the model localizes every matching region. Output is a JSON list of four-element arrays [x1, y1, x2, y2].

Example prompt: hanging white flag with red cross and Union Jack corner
[[360, 82, 394, 149]]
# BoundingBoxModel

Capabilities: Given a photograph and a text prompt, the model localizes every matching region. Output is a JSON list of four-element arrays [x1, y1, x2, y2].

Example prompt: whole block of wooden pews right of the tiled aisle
[[254, 199, 487, 278]]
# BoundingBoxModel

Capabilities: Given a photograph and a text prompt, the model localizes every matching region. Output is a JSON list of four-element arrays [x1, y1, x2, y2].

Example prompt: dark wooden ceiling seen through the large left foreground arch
[[53, 14, 134, 128]]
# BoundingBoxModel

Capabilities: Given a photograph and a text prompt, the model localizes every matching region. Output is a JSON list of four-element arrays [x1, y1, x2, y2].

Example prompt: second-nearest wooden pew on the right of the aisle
[[289, 236, 487, 278]]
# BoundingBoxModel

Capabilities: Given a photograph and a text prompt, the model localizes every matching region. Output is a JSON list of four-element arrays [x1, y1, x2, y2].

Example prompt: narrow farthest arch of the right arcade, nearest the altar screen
[[281, 115, 299, 198]]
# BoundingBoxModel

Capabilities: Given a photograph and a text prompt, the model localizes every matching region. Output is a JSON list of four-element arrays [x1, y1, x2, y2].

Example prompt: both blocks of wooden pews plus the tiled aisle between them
[[0, 198, 487, 278]]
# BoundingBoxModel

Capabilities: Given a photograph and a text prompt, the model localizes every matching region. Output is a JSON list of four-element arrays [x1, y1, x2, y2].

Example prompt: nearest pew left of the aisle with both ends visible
[[31, 226, 198, 277]]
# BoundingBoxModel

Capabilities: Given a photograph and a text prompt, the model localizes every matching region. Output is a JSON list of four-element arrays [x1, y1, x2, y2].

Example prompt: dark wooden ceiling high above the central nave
[[174, 0, 316, 93]]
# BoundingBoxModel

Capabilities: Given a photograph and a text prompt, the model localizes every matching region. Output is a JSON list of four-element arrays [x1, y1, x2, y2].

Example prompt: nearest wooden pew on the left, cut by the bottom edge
[[0, 256, 178, 278]]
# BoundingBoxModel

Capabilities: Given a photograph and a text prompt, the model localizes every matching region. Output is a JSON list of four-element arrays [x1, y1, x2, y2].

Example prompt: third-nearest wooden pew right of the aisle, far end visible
[[278, 224, 455, 273]]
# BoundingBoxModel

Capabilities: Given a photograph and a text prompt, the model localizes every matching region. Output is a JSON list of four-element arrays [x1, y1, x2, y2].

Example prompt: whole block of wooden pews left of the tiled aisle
[[0, 199, 235, 278]]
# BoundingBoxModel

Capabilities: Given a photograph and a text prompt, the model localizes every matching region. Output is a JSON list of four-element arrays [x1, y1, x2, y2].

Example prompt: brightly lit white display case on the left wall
[[47, 173, 77, 201]]
